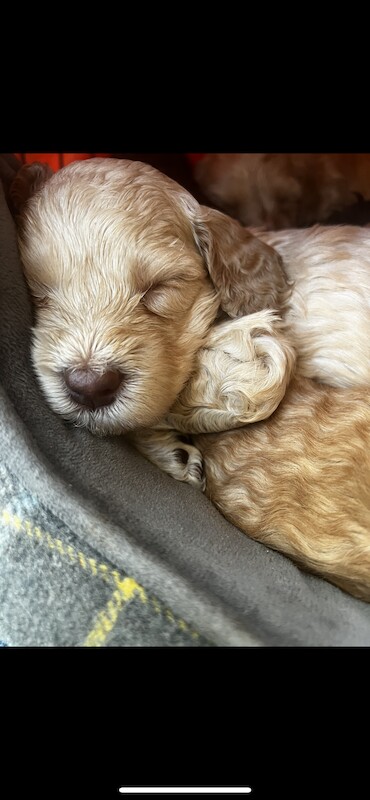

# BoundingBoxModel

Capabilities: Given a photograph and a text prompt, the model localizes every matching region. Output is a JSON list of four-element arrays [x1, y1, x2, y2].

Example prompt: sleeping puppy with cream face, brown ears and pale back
[[8, 159, 370, 434]]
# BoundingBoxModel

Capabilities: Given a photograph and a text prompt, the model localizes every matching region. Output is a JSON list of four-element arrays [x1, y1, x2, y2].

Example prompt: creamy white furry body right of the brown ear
[[254, 225, 370, 386]]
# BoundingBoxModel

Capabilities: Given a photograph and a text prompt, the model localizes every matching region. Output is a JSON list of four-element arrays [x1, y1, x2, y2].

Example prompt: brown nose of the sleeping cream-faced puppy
[[64, 369, 123, 409]]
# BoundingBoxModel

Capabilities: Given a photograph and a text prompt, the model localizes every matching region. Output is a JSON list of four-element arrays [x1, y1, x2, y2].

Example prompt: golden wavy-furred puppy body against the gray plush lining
[[194, 379, 370, 601]]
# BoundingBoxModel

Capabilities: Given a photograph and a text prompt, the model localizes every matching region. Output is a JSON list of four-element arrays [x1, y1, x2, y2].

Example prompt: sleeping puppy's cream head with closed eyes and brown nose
[[12, 154, 290, 433]]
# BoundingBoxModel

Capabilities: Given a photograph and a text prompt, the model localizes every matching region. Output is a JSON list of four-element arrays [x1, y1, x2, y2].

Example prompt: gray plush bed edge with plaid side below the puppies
[[0, 156, 370, 646]]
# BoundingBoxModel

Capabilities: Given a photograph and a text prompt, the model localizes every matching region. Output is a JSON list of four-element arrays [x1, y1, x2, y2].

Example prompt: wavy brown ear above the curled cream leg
[[194, 206, 290, 317]]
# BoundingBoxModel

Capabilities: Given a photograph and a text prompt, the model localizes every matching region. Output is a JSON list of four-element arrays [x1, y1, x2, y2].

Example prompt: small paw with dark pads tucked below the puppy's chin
[[129, 423, 205, 491]]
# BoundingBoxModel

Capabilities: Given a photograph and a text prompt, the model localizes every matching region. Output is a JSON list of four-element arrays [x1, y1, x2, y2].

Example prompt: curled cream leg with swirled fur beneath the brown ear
[[166, 310, 295, 433]]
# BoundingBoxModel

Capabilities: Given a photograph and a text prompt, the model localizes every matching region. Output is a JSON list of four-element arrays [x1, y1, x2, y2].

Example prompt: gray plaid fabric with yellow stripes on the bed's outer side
[[0, 456, 209, 647]]
